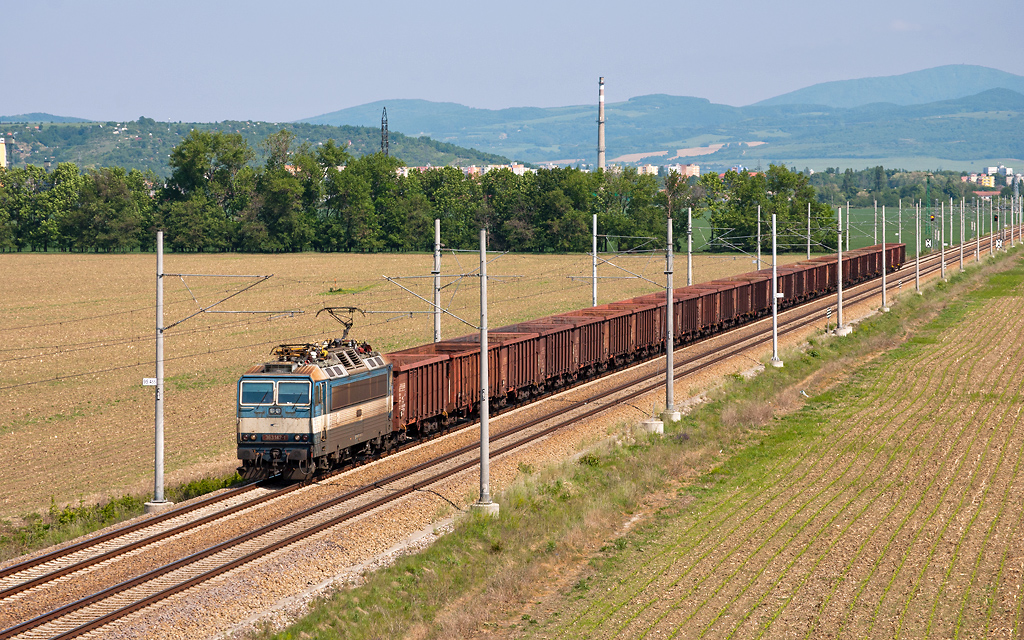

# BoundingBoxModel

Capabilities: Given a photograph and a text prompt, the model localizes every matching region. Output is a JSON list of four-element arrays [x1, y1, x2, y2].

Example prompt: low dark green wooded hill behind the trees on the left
[[0, 118, 509, 176]]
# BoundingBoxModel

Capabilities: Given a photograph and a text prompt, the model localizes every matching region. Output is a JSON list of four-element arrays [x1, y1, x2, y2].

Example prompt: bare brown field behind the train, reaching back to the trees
[[0, 253, 802, 518]]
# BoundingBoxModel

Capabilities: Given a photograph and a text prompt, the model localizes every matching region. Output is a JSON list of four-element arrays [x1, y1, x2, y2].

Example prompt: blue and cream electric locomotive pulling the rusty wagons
[[237, 340, 392, 478]]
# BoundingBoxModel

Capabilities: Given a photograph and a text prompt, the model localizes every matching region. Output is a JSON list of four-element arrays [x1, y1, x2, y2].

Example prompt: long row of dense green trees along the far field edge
[[0, 130, 897, 253]]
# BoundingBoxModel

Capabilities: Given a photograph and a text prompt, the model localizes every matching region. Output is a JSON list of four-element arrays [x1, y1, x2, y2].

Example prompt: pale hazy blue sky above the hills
[[0, 0, 1024, 122]]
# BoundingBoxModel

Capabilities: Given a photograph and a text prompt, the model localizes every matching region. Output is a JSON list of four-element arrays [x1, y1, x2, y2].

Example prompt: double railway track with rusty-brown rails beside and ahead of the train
[[0, 239, 1007, 640]]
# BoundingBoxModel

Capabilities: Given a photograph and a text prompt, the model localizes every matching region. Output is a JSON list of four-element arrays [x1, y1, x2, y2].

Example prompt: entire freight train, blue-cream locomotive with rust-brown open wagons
[[237, 244, 906, 478]]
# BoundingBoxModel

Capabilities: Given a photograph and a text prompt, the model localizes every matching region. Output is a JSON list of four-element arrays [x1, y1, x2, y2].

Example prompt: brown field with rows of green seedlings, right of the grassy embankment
[[507, 258, 1024, 638]]
